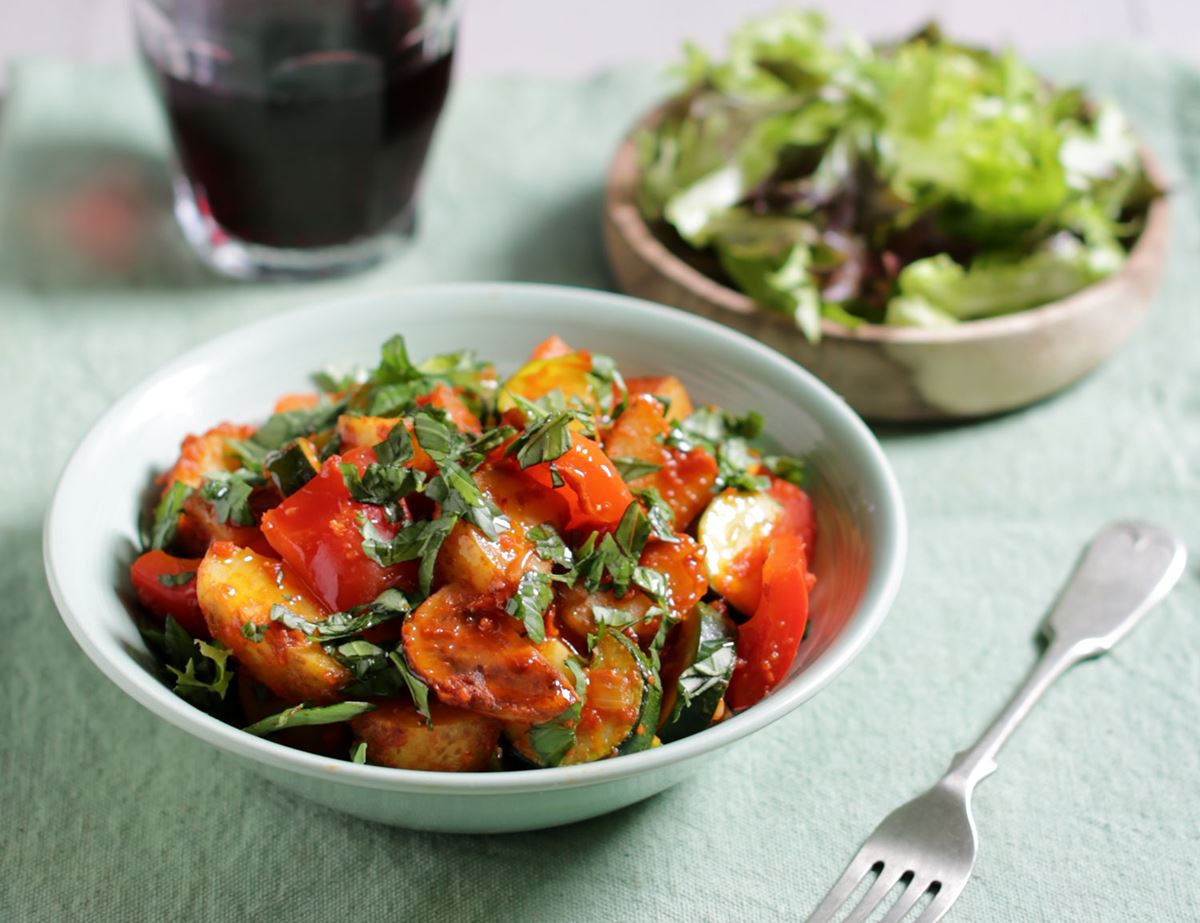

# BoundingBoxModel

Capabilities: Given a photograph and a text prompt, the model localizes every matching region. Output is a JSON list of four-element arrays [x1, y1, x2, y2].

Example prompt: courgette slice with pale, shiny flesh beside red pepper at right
[[697, 490, 784, 616]]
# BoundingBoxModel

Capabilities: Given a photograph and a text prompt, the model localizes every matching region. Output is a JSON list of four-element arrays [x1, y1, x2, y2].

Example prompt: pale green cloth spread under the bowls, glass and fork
[[0, 49, 1200, 923]]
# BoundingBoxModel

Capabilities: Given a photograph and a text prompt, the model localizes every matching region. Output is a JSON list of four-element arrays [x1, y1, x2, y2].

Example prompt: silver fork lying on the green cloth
[[809, 522, 1187, 923]]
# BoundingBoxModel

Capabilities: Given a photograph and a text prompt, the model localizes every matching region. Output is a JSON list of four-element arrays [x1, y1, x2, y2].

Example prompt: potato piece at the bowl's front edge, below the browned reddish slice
[[350, 700, 500, 772]]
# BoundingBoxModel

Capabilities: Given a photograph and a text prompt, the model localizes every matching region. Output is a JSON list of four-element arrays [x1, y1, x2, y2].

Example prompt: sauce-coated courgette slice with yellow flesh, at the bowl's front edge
[[506, 631, 662, 766]]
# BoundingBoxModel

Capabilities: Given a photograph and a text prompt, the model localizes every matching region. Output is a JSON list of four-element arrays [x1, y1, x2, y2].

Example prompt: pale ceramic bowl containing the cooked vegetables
[[44, 284, 906, 832]]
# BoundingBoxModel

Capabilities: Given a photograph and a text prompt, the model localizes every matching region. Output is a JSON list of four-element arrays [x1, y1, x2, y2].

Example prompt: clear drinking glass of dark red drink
[[133, 0, 458, 278]]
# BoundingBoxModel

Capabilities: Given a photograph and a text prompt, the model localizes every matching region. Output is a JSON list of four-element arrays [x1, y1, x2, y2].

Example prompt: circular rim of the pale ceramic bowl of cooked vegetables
[[42, 282, 907, 795]]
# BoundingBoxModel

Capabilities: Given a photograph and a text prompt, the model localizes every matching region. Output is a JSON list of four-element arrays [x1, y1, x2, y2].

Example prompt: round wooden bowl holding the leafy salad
[[605, 108, 1169, 421]]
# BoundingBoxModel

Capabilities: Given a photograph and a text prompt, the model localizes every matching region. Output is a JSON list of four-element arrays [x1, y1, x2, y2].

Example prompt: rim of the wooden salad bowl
[[604, 97, 1170, 346]]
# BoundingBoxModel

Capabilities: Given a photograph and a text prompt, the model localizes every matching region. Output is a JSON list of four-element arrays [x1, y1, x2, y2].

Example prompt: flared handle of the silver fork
[[944, 522, 1187, 792]]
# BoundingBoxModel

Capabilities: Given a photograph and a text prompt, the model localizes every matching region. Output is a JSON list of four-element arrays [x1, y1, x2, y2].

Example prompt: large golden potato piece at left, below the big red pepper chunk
[[196, 541, 350, 703]]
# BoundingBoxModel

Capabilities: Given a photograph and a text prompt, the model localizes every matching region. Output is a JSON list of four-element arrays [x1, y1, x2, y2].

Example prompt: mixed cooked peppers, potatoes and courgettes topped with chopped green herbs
[[131, 336, 815, 772]]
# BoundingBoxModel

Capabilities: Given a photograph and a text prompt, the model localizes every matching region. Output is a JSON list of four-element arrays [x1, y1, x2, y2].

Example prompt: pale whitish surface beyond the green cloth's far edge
[[0, 0, 1200, 85]]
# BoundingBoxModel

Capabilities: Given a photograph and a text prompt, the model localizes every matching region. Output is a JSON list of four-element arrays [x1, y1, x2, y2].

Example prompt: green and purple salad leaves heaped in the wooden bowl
[[637, 11, 1159, 340]]
